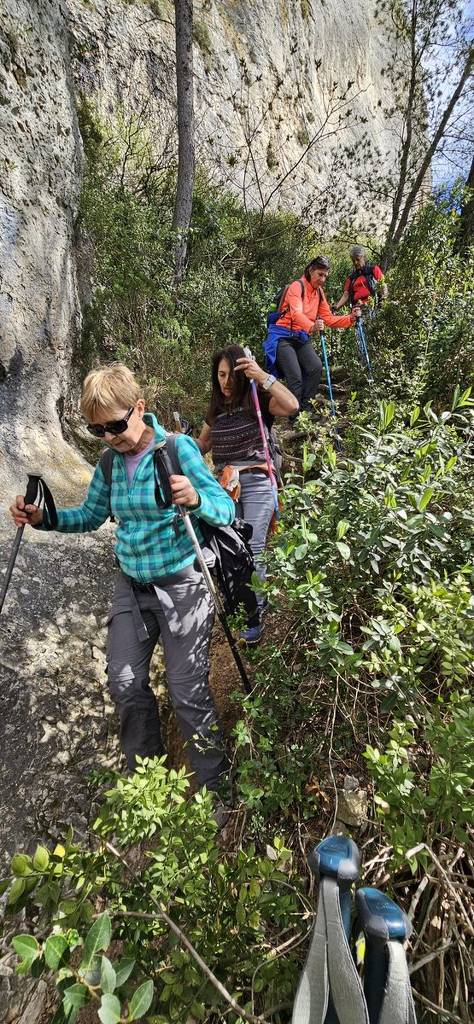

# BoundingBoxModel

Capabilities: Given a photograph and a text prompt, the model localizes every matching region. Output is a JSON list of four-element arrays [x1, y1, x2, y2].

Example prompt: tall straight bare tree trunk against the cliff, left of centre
[[173, 0, 195, 286]]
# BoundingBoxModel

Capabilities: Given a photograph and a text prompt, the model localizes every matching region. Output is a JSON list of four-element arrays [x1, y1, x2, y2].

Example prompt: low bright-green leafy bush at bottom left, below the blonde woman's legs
[[3, 759, 301, 1024]]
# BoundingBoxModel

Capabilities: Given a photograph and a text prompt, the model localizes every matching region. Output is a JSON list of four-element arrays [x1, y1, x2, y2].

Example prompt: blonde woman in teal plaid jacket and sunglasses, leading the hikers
[[10, 362, 234, 788]]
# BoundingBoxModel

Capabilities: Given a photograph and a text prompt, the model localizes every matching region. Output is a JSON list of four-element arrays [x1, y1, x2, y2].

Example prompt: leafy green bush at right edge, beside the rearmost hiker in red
[[370, 191, 474, 402]]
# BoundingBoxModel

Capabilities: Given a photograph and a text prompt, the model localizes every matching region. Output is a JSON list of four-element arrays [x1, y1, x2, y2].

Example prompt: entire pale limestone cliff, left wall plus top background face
[[0, 0, 401, 501]]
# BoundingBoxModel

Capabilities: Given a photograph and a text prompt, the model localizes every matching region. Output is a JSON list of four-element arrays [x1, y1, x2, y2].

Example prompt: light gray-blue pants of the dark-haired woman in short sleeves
[[236, 470, 274, 609]]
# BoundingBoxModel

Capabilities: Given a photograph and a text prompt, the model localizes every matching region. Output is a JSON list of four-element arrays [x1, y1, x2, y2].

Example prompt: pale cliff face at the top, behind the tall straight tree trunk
[[67, 0, 393, 214]]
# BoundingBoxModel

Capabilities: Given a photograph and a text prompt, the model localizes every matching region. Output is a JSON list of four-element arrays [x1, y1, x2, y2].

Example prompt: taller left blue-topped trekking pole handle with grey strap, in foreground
[[292, 836, 370, 1024]]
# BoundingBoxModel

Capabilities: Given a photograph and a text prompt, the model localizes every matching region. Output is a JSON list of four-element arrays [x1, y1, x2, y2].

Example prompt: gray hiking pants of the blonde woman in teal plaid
[[107, 566, 228, 790]]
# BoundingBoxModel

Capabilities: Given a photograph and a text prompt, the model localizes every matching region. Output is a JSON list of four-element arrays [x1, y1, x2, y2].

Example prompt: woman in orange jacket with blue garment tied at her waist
[[263, 256, 360, 422]]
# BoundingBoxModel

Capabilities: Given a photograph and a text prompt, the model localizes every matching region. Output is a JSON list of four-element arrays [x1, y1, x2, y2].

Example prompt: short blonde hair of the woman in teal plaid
[[81, 362, 141, 423]]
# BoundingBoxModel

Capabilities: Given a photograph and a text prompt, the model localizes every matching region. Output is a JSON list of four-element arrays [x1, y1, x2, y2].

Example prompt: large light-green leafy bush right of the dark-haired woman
[[236, 393, 474, 835]]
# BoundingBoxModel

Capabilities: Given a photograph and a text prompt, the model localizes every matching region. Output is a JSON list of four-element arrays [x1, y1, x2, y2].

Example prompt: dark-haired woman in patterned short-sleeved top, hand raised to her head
[[198, 345, 298, 643]]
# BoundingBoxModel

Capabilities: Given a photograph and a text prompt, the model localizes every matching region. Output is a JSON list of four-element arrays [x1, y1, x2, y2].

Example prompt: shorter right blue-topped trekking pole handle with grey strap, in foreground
[[355, 888, 417, 1024]]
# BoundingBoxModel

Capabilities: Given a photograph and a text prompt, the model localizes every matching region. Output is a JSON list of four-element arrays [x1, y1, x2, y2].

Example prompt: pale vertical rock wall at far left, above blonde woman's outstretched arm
[[0, 0, 88, 500]]
